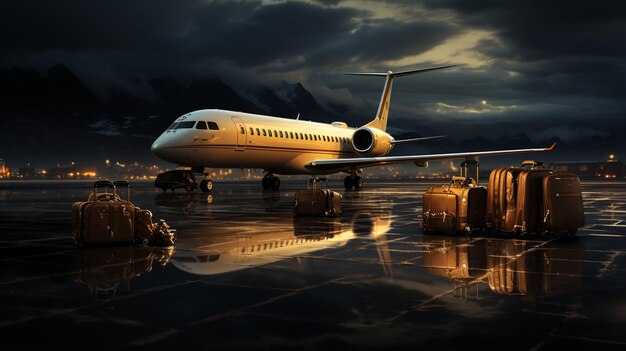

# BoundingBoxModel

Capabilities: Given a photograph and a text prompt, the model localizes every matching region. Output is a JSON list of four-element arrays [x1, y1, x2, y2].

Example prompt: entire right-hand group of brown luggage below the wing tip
[[422, 161, 585, 234]]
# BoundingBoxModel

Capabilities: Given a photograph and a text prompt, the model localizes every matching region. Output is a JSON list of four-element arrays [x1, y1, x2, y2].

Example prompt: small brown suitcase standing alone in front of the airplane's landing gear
[[294, 178, 342, 217]]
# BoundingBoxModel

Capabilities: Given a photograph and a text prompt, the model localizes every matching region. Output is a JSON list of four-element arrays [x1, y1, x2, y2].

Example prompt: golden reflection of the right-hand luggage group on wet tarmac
[[424, 236, 585, 296]]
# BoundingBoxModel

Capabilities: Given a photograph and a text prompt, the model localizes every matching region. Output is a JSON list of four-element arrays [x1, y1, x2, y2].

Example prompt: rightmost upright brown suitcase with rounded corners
[[542, 172, 585, 233]]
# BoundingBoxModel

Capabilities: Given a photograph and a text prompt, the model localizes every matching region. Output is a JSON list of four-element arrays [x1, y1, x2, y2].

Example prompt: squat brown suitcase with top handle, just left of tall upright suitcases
[[422, 177, 487, 232]]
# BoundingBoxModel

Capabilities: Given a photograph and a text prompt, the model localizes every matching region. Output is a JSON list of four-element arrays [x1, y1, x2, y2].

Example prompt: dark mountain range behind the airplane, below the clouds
[[0, 64, 626, 168]]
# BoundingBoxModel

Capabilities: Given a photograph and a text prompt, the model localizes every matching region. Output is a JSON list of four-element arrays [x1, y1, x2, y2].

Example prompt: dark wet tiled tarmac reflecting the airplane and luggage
[[0, 181, 626, 349]]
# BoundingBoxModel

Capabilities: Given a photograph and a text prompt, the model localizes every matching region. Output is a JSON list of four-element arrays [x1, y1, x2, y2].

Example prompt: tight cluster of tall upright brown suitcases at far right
[[486, 161, 585, 233]]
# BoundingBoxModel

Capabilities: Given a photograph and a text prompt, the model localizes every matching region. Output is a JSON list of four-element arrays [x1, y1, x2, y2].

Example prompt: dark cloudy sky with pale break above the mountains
[[0, 0, 626, 141]]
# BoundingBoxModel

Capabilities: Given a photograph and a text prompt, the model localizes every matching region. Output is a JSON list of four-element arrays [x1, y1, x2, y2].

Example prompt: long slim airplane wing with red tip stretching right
[[305, 143, 556, 172]]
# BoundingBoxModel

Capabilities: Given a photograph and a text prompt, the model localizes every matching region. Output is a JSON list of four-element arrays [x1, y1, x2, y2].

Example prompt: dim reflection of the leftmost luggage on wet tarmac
[[72, 245, 174, 300]]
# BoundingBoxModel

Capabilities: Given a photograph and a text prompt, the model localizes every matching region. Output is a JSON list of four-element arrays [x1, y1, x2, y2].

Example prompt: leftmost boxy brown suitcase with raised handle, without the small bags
[[72, 181, 135, 245]]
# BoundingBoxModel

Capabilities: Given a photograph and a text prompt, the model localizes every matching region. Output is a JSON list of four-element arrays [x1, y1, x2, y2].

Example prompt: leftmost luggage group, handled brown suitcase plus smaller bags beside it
[[72, 180, 176, 246]]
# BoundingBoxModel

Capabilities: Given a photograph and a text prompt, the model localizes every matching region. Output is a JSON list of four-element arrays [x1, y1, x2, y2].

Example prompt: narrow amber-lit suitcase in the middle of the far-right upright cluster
[[514, 169, 553, 233]]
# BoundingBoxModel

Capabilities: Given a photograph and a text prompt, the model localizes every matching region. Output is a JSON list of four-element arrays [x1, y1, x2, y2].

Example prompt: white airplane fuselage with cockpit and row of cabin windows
[[152, 109, 386, 174]]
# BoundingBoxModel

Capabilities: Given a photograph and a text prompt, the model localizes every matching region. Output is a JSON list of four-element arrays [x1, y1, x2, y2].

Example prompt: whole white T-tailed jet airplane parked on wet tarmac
[[151, 65, 556, 192]]
